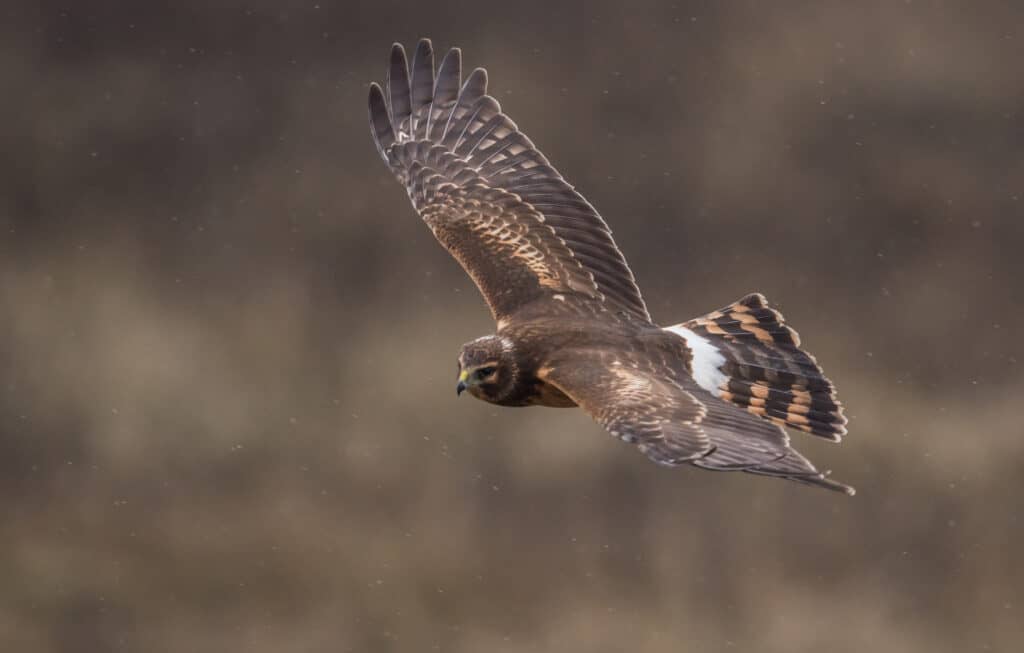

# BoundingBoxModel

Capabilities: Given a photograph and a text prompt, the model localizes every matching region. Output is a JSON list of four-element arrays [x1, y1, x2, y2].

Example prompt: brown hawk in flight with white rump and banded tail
[[370, 39, 854, 494]]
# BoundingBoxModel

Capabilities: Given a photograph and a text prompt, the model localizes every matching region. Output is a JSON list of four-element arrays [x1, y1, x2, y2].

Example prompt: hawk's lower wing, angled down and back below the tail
[[539, 350, 854, 494]]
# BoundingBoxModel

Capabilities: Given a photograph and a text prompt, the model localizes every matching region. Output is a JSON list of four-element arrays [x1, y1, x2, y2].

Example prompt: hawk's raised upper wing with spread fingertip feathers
[[370, 39, 650, 322]]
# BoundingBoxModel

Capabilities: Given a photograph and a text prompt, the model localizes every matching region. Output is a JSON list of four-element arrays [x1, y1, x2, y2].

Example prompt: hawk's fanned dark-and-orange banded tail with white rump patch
[[668, 293, 847, 442]]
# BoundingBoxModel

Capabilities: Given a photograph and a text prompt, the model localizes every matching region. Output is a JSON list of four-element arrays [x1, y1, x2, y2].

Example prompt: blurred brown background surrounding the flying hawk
[[0, 0, 1024, 653]]
